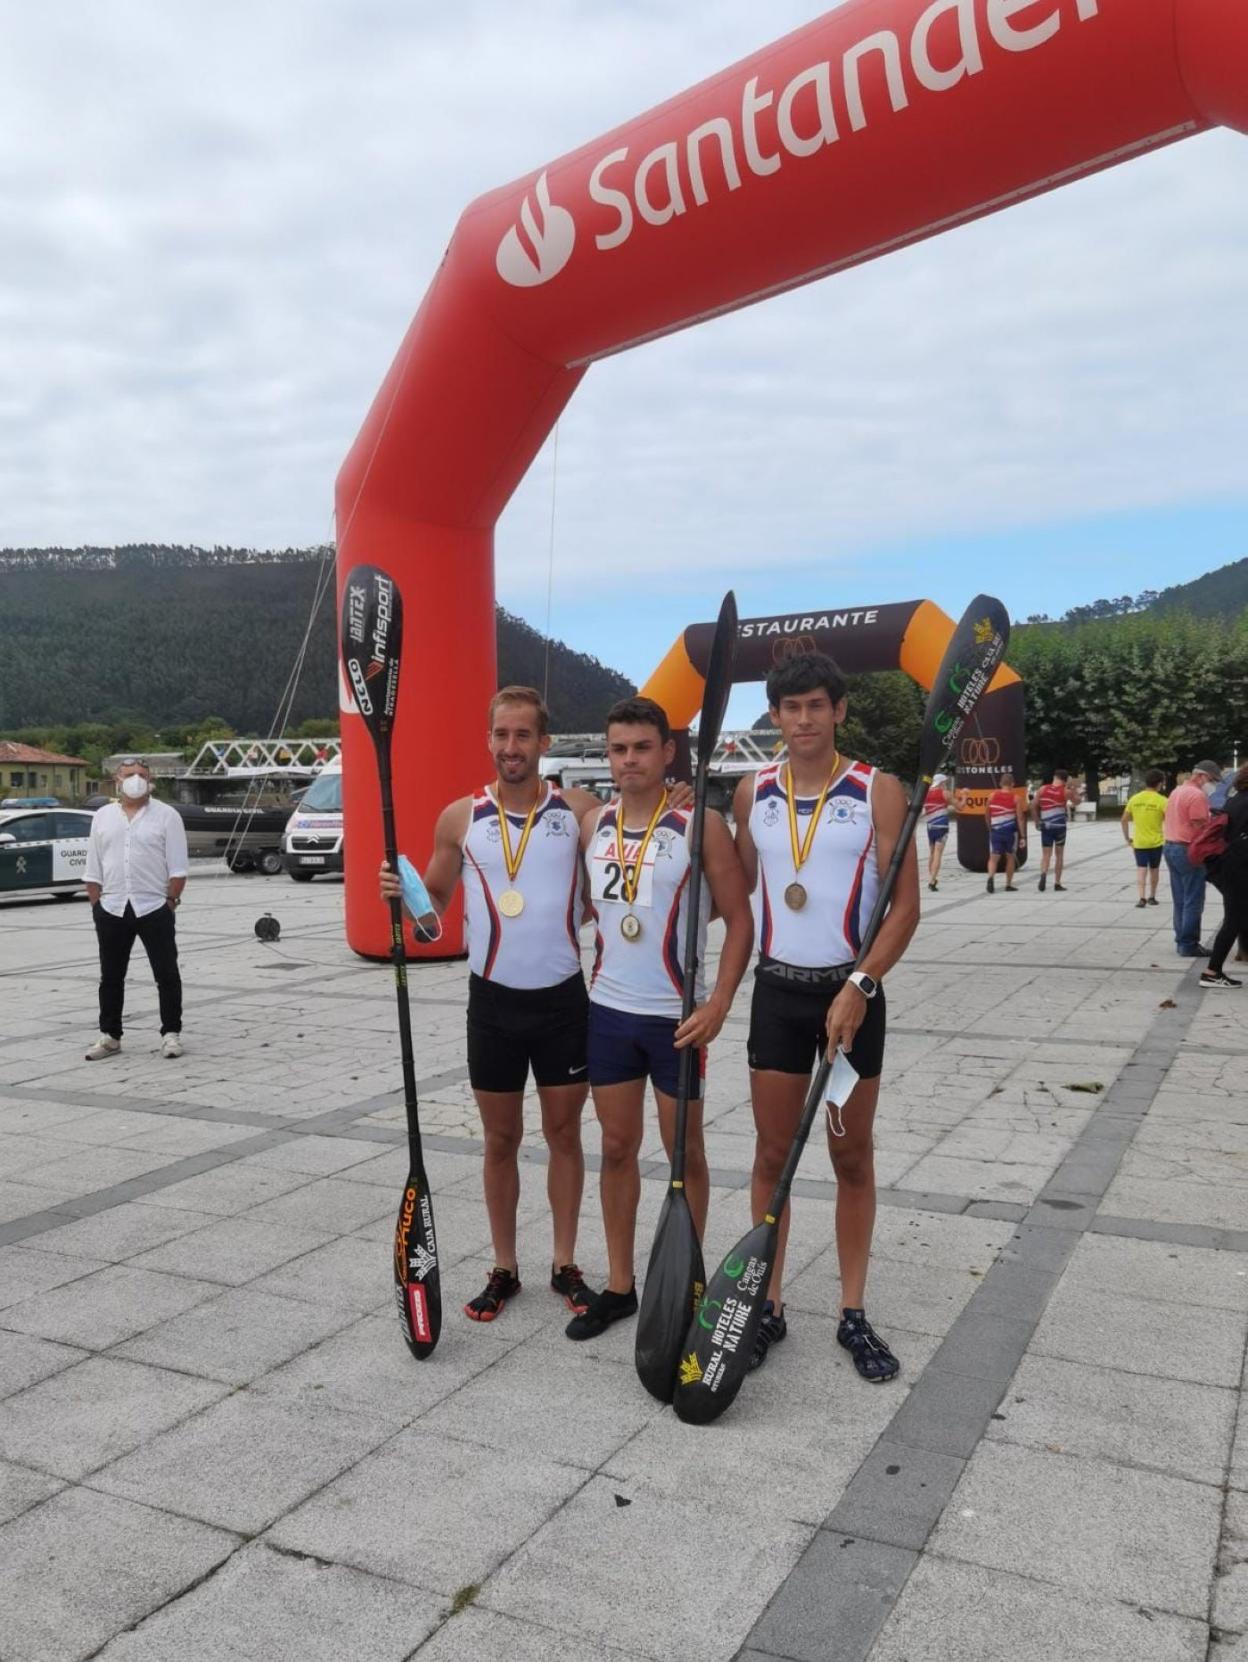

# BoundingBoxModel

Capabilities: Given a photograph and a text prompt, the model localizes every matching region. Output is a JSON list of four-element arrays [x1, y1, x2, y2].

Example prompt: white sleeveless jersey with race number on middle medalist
[[587, 799, 711, 1019]]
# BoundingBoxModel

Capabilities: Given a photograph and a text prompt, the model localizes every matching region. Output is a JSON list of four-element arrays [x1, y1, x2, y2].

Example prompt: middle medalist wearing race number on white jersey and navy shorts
[[567, 698, 753, 1340]]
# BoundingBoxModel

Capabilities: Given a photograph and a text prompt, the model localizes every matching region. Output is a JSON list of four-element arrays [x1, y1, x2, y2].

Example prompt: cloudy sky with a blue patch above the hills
[[9, 0, 1248, 715]]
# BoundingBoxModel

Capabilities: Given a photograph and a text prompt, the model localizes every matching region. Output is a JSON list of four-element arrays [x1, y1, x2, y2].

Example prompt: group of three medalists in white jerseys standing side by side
[[381, 655, 919, 1383]]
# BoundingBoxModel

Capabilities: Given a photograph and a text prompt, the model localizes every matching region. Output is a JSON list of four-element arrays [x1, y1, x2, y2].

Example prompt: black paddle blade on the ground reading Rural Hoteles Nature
[[671, 1222, 779, 1426]]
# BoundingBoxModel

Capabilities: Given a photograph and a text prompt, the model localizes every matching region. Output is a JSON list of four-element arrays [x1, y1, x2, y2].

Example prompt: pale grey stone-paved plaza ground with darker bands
[[0, 824, 1248, 1662]]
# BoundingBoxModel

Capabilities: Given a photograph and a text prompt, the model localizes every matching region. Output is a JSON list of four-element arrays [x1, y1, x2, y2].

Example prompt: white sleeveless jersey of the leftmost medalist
[[462, 784, 582, 987]]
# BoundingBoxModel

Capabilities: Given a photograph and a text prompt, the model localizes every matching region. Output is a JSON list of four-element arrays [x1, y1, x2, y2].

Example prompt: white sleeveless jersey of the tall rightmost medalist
[[749, 761, 879, 969]]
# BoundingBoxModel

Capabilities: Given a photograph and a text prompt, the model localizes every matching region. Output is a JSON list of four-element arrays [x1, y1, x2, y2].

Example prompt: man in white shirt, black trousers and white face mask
[[86, 756, 186, 1062]]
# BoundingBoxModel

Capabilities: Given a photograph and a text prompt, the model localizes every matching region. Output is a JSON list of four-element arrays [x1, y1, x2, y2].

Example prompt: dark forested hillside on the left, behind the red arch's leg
[[0, 547, 633, 733]]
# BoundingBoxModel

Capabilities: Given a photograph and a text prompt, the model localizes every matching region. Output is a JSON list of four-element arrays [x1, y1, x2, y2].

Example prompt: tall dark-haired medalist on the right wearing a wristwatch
[[733, 653, 919, 1381]]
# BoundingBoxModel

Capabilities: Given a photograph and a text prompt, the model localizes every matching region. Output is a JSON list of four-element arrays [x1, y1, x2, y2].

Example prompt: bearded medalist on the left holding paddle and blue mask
[[382, 686, 621, 1321]]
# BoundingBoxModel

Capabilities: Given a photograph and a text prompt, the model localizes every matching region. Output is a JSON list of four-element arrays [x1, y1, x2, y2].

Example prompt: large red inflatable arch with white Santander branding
[[337, 0, 1248, 956]]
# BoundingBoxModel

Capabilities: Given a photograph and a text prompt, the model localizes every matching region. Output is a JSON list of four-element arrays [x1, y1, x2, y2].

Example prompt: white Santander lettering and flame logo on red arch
[[495, 0, 1100, 289]]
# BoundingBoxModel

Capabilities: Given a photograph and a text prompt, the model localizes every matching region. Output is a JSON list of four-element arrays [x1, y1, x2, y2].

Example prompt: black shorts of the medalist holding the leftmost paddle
[[469, 971, 590, 1090]]
